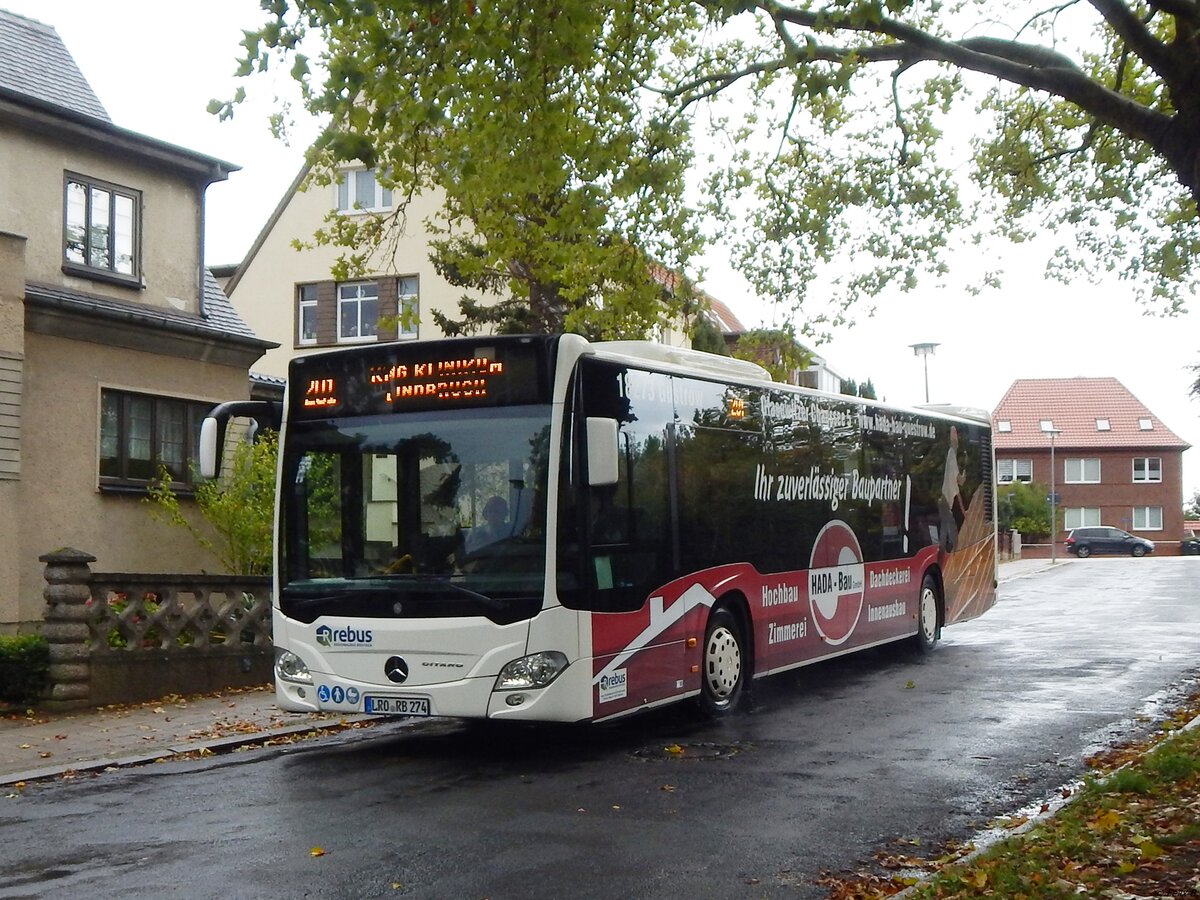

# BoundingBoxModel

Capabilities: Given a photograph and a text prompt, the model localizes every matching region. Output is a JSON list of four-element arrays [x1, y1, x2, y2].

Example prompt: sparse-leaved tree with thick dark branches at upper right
[[664, 0, 1200, 324]]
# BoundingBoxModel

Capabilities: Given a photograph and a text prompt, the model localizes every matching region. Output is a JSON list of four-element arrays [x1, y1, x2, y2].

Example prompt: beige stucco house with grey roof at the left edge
[[0, 11, 272, 631]]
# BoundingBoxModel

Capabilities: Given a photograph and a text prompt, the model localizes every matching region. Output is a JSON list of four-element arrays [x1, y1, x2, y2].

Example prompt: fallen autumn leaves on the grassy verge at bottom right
[[817, 692, 1200, 900]]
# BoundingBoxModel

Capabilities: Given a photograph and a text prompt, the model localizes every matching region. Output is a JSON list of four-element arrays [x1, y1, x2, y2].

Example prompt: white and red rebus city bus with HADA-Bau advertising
[[203, 335, 996, 721]]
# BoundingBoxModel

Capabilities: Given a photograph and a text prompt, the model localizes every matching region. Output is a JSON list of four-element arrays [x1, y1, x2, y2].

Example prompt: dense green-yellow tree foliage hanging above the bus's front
[[225, 0, 698, 337]]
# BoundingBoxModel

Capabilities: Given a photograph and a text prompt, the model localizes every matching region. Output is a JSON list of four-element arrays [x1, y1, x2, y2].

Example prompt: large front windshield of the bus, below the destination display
[[280, 406, 550, 623]]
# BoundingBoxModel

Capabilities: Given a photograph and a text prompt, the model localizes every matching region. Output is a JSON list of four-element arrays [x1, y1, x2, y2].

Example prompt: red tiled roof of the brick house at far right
[[991, 378, 1190, 450]]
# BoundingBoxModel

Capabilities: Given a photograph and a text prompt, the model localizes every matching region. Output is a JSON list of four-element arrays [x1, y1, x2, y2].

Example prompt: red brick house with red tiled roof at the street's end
[[992, 378, 1189, 553]]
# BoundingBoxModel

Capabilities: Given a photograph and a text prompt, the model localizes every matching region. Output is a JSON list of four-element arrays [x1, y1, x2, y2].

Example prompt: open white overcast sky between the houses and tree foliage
[[9, 0, 1200, 501]]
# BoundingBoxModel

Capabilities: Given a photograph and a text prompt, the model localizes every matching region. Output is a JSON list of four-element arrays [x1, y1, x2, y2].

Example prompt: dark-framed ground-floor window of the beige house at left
[[100, 389, 212, 488]]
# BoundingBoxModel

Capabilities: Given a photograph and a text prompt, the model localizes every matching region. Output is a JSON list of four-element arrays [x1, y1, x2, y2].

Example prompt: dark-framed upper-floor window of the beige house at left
[[62, 174, 142, 281]]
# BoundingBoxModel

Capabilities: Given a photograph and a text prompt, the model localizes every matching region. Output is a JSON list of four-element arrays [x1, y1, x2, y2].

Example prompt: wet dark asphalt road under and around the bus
[[0, 558, 1200, 900]]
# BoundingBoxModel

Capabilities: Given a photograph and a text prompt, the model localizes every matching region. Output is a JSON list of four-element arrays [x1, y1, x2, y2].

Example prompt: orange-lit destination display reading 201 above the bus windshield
[[288, 337, 553, 419]]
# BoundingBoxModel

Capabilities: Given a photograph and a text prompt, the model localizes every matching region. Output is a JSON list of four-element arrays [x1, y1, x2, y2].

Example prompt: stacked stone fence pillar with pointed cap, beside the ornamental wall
[[37, 547, 96, 709]]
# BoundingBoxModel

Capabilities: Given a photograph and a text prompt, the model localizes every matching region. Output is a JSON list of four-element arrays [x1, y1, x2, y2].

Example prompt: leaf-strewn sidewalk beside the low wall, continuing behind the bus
[[0, 559, 1072, 785]]
